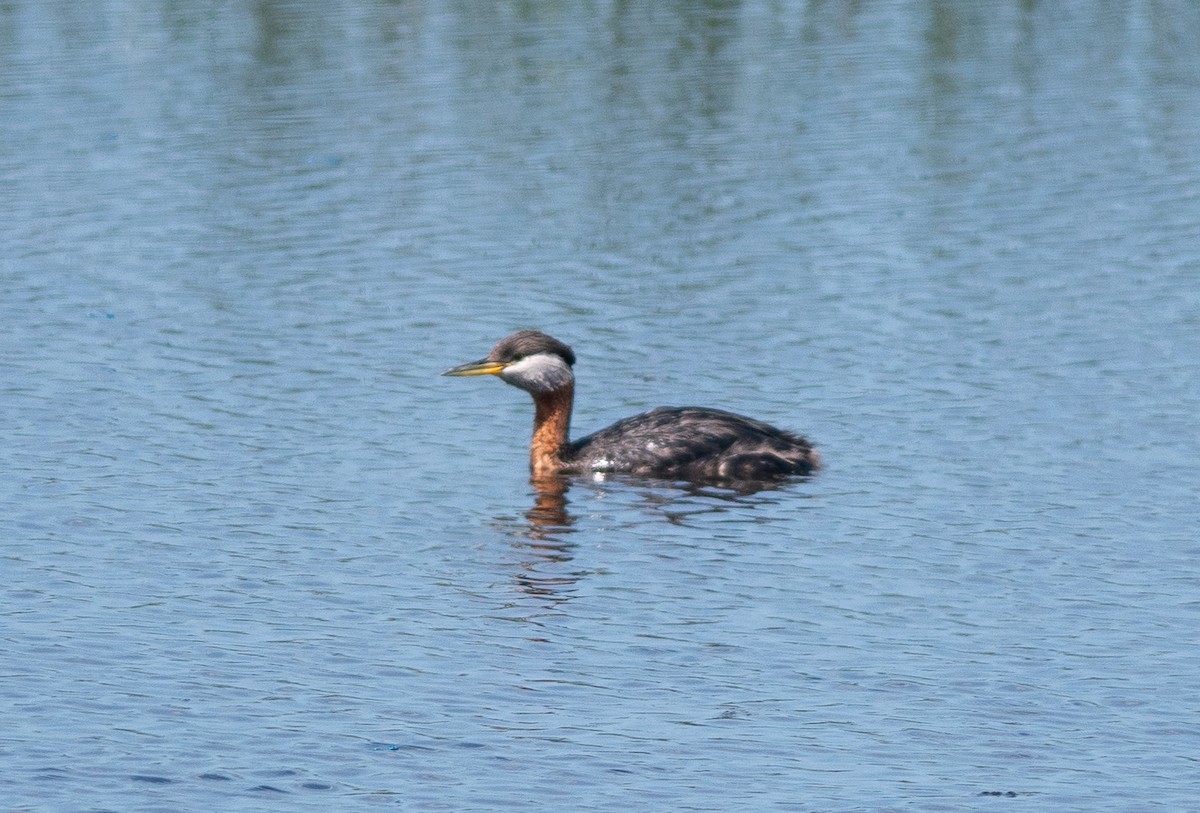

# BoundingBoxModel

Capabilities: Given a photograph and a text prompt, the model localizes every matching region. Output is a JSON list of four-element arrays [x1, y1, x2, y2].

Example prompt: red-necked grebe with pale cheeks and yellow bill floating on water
[[442, 330, 821, 481]]
